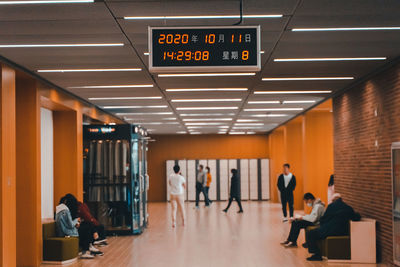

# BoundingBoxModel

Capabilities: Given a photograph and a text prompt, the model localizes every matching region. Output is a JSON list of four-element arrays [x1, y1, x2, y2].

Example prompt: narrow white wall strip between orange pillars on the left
[[40, 108, 54, 219]]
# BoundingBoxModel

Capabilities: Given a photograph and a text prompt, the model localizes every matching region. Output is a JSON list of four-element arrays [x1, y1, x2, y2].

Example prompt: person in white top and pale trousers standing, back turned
[[168, 165, 186, 227]]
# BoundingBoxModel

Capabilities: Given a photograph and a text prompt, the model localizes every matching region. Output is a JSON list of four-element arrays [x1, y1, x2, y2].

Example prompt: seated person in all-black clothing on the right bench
[[306, 193, 361, 261]]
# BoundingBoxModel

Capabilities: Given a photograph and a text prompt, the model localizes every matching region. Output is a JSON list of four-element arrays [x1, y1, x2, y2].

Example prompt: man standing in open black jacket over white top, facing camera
[[277, 163, 296, 222]]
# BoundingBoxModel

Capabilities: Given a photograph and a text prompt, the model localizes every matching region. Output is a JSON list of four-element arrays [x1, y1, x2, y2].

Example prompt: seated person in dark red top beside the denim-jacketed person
[[65, 194, 104, 256]]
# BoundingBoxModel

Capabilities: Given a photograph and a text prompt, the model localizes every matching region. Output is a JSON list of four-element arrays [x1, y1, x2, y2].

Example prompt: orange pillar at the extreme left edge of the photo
[[0, 64, 16, 267]]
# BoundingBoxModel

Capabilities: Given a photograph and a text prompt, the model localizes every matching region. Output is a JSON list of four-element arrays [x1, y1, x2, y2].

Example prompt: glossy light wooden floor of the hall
[[46, 201, 384, 267]]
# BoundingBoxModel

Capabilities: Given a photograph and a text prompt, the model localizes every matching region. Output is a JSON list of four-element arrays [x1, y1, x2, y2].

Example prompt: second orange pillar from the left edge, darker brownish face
[[16, 74, 42, 266]]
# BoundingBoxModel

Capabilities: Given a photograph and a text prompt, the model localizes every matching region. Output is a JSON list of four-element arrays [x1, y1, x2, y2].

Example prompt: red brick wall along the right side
[[333, 64, 400, 263]]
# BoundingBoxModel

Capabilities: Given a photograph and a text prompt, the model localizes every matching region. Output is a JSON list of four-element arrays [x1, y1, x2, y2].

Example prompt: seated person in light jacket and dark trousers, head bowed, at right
[[281, 193, 325, 248]]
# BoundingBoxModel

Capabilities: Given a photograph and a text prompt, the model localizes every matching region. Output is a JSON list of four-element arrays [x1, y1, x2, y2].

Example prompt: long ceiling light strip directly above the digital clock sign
[[124, 14, 283, 20]]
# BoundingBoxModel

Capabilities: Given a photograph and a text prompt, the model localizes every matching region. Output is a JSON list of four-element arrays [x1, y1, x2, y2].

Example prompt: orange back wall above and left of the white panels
[[148, 135, 269, 201]]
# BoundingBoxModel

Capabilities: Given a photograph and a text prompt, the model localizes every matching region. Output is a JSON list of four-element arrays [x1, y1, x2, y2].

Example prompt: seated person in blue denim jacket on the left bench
[[55, 196, 101, 259]]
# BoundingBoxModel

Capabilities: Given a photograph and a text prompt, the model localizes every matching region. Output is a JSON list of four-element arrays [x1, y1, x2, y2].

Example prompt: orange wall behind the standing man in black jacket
[[268, 100, 333, 209]]
